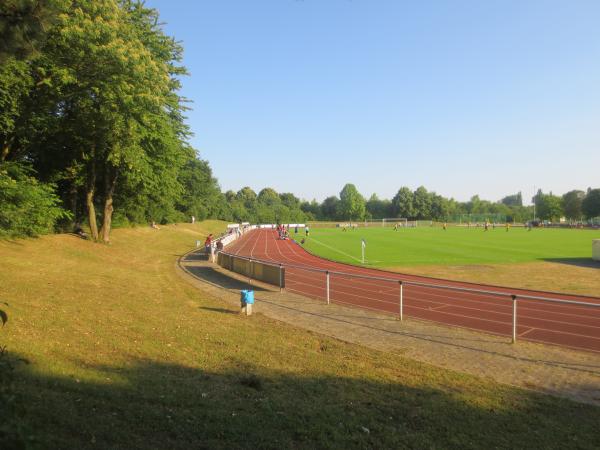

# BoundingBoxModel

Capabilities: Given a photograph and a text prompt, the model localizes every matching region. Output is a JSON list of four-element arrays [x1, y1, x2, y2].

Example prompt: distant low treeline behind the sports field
[[222, 184, 600, 223]]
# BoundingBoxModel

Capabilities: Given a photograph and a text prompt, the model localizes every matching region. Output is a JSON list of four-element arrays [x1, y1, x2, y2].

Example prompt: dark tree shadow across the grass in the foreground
[[8, 349, 600, 449]]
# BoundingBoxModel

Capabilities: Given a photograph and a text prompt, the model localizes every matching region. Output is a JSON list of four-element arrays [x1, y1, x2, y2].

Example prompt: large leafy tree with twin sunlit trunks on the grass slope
[[22, 0, 189, 242]]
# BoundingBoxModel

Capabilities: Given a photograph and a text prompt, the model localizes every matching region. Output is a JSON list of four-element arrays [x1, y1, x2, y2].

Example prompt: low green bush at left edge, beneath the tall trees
[[0, 163, 71, 238]]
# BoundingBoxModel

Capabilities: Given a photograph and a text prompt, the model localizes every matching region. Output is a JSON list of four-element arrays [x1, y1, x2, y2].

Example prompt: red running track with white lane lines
[[227, 229, 600, 352]]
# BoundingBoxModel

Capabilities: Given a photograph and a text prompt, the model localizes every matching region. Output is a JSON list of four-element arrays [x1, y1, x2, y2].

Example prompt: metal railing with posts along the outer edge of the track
[[216, 252, 600, 343]]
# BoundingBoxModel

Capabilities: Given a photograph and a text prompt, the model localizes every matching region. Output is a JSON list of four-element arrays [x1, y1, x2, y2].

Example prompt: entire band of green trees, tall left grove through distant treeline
[[0, 0, 600, 242]]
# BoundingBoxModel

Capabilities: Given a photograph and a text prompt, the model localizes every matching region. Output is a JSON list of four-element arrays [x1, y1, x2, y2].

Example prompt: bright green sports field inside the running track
[[304, 227, 600, 267]]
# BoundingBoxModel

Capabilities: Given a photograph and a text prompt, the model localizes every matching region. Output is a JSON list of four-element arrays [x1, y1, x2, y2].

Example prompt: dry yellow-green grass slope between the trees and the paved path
[[0, 222, 600, 449]]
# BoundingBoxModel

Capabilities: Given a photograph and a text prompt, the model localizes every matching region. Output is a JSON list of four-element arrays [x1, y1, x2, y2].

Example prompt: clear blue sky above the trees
[[147, 0, 600, 200]]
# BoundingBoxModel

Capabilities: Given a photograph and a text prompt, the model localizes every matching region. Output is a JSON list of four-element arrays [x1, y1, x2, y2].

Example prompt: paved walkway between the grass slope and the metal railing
[[177, 248, 600, 405]]
